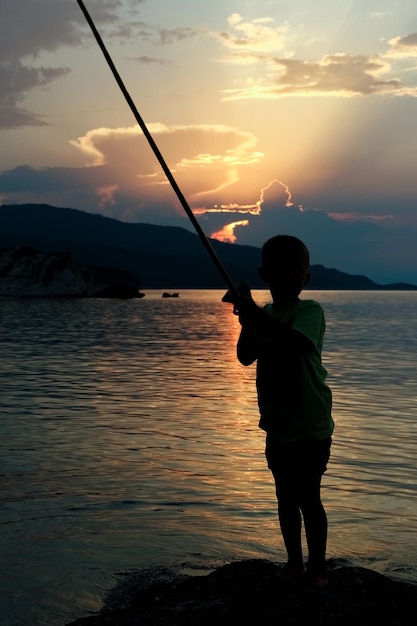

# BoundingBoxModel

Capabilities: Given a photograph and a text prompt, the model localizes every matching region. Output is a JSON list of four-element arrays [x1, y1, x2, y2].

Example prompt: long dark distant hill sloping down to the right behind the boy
[[0, 204, 417, 290]]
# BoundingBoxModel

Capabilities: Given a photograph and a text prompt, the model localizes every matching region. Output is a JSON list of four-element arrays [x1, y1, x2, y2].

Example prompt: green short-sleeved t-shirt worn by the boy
[[256, 300, 334, 441]]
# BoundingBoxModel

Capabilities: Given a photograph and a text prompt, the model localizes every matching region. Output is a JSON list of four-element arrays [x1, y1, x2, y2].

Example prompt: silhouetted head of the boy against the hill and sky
[[259, 235, 310, 300]]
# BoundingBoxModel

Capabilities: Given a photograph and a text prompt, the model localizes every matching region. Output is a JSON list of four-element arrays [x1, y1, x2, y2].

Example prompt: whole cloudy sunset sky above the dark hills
[[0, 0, 417, 284]]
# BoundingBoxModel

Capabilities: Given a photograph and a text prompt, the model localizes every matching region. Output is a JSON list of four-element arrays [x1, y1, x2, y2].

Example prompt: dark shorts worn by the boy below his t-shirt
[[265, 435, 332, 478]]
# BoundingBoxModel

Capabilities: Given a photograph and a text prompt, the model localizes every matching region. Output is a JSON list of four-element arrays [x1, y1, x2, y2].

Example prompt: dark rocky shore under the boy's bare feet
[[67, 560, 417, 626]]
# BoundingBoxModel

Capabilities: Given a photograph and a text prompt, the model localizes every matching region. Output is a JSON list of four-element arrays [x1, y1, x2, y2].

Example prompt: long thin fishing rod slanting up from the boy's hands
[[77, 0, 239, 296]]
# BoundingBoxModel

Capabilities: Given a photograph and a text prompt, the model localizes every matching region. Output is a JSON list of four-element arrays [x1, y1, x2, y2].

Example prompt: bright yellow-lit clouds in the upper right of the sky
[[214, 14, 417, 101]]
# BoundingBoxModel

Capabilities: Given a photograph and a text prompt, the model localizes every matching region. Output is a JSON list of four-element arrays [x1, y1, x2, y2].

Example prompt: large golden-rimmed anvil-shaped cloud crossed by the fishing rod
[[67, 123, 264, 218]]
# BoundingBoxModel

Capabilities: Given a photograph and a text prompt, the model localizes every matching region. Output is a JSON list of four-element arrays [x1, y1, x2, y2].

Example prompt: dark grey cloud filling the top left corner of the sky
[[0, 0, 144, 128]]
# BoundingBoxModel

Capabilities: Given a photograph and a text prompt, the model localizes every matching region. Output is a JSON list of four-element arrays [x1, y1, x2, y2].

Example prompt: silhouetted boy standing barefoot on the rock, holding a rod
[[225, 235, 334, 587]]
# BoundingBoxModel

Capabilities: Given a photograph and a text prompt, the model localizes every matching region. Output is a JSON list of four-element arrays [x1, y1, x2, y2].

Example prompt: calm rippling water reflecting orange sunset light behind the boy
[[0, 291, 417, 626]]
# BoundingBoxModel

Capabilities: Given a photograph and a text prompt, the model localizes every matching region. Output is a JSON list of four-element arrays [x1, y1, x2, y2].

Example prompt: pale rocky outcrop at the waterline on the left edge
[[0, 246, 95, 297]]
